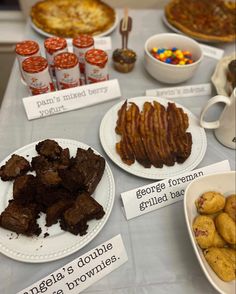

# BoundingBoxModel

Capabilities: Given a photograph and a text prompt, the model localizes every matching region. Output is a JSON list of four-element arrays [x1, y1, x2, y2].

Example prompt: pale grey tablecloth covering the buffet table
[[0, 10, 235, 294]]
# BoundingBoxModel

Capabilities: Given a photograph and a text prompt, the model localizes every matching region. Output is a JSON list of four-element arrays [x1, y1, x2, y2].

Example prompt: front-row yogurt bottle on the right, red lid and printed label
[[85, 49, 109, 84]]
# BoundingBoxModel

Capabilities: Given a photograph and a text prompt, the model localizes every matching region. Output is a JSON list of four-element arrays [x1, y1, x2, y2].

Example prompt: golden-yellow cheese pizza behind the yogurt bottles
[[31, 0, 115, 38]]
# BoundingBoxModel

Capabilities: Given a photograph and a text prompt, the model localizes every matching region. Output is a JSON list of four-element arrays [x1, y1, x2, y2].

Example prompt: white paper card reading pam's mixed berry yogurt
[[23, 79, 121, 120]]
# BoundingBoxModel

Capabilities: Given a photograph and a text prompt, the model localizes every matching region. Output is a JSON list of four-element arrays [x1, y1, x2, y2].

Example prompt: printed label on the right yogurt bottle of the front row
[[85, 62, 109, 84]]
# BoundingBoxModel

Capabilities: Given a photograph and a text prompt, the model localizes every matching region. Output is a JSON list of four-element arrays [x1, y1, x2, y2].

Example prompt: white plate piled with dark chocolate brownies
[[0, 139, 115, 263]]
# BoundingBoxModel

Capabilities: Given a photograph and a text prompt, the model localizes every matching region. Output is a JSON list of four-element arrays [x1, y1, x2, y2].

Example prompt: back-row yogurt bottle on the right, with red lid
[[72, 35, 94, 76]]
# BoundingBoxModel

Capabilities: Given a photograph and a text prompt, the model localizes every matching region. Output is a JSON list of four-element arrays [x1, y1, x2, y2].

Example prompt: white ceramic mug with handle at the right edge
[[200, 88, 236, 149]]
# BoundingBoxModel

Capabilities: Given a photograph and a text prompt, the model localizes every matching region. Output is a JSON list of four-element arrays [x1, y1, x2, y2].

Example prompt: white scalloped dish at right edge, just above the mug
[[211, 52, 236, 97]]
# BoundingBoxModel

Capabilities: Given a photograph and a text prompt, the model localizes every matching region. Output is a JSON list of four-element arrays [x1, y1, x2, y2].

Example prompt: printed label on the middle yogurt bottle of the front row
[[55, 64, 80, 90]]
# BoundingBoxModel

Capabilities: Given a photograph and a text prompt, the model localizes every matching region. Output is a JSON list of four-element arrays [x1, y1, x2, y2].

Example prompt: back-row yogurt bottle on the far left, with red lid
[[15, 40, 41, 80]]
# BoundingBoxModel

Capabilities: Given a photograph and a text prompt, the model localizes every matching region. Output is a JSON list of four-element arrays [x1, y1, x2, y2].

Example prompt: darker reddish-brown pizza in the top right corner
[[165, 0, 236, 42]]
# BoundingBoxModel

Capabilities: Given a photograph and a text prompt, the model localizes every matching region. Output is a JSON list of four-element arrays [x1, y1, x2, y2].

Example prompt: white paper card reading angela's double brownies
[[18, 235, 128, 294]]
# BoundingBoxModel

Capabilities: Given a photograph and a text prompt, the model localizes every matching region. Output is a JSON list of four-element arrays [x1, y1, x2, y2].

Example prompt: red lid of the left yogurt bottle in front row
[[22, 56, 48, 73]]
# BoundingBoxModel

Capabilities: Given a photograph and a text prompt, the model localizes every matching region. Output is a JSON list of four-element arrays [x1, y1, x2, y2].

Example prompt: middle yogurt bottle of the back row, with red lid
[[44, 37, 68, 78]]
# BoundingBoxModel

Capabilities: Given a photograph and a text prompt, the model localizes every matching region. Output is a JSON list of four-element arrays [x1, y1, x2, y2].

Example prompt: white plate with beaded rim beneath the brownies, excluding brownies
[[0, 139, 115, 263]]
